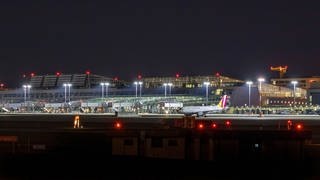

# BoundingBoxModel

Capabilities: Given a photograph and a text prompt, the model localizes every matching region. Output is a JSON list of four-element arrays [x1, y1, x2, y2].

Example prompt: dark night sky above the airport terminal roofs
[[0, 0, 320, 86]]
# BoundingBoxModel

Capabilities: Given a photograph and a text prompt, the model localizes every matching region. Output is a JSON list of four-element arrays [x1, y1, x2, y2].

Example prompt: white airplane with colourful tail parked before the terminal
[[180, 95, 227, 117]]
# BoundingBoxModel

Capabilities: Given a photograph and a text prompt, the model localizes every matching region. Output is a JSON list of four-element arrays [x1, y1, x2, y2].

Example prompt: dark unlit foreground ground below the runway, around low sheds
[[0, 115, 320, 180]]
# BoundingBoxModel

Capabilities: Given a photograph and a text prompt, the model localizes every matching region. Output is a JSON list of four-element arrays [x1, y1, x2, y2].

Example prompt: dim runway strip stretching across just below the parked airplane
[[0, 113, 320, 131]]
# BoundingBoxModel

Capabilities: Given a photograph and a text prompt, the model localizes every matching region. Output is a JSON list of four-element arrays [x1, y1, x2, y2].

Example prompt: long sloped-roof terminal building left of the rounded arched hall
[[0, 74, 243, 103]]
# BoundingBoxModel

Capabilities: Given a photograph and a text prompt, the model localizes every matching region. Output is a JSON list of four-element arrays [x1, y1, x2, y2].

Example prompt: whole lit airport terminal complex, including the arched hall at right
[[0, 73, 313, 112]]
